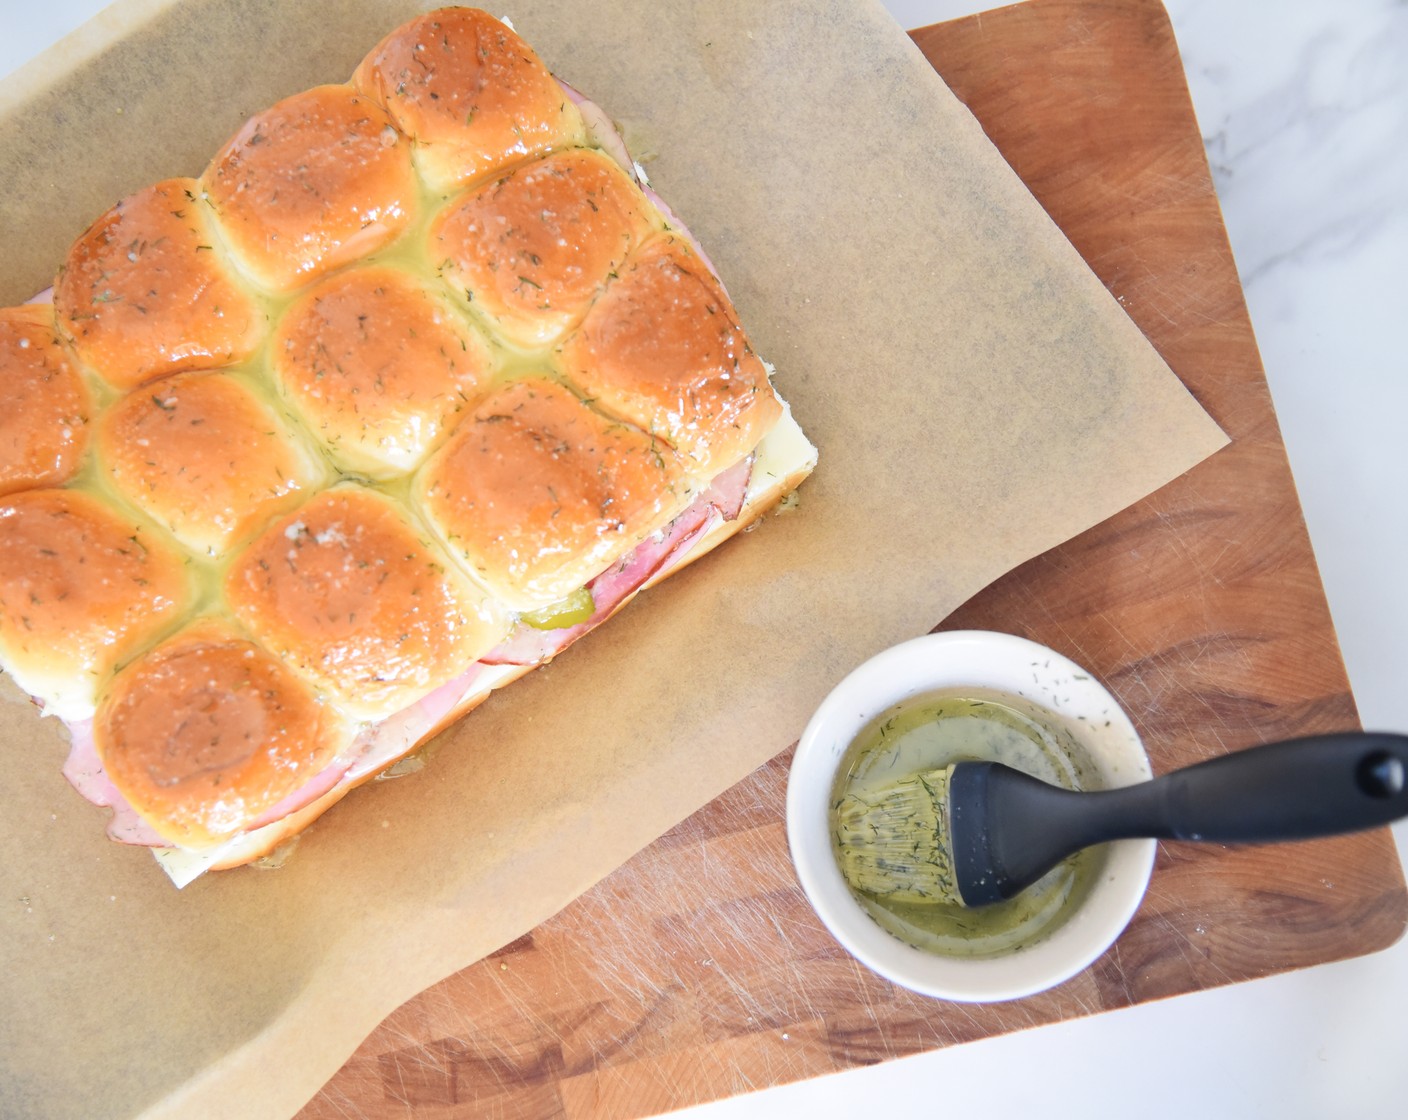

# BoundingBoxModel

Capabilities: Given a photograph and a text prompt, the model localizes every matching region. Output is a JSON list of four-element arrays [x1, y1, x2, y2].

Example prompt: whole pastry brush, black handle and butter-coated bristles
[[836, 731, 1408, 906]]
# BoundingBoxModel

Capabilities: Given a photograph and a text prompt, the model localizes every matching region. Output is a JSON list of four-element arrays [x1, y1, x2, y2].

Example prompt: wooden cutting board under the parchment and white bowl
[[301, 0, 1408, 1120]]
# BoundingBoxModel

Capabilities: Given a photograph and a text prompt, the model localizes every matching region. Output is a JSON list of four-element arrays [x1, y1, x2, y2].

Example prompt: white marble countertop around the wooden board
[[0, 0, 1408, 1120]]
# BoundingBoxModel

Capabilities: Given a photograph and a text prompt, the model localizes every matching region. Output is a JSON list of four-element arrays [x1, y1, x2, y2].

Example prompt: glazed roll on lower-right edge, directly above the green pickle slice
[[417, 378, 690, 610]]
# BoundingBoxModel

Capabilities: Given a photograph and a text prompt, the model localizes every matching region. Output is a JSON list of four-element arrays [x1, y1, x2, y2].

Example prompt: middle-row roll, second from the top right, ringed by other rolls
[[270, 268, 493, 478]]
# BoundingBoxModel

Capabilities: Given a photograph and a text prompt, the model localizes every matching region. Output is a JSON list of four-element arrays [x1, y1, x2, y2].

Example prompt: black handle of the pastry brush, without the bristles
[[949, 731, 1408, 906]]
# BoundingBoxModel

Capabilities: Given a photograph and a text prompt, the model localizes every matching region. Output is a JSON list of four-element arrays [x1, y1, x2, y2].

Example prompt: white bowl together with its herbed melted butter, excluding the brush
[[787, 631, 1156, 1002]]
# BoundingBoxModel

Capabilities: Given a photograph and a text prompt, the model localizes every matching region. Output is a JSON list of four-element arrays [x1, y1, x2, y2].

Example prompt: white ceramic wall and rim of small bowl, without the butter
[[787, 630, 1156, 1003]]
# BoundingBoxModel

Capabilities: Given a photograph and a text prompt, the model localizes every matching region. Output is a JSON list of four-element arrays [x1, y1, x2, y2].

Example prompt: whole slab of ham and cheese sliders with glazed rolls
[[0, 8, 815, 885]]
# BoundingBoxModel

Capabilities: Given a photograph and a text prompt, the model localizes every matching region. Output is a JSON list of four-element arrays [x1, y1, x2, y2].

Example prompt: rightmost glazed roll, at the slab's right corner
[[563, 235, 781, 475]]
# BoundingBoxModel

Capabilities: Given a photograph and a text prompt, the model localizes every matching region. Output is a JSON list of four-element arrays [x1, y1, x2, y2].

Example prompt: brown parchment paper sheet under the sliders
[[0, 0, 1224, 1120]]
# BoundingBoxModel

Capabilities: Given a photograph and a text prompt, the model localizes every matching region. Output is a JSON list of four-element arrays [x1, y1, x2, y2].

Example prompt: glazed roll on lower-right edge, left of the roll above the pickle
[[225, 485, 508, 718]]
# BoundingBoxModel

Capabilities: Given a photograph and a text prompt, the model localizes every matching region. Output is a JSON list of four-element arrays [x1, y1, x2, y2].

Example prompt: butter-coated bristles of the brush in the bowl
[[836, 766, 963, 906]]
